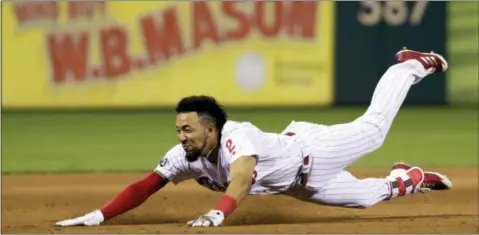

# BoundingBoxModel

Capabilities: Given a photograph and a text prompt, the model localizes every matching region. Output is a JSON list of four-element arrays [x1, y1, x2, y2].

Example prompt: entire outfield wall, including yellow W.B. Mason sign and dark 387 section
[[2, 1, 478, 109]]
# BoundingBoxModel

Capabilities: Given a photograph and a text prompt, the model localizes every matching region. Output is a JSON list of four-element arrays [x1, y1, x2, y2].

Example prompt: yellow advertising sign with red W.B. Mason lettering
[[2, 1, 334, 108]]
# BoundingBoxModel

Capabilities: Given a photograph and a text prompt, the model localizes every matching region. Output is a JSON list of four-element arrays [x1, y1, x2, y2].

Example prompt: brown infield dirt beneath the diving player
[[2, 168, 479, 233]]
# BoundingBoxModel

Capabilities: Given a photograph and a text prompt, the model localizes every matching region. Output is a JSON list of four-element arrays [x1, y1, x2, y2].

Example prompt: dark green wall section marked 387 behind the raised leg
[[335, 1, 447, 104]]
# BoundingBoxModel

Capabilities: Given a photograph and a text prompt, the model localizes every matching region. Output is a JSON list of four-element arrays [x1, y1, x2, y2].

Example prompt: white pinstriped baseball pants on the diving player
[[283, 60, 428, 208]]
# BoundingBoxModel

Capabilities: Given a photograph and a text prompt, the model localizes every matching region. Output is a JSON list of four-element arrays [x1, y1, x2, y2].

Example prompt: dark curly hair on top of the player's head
[[176, 95, 228, 134]]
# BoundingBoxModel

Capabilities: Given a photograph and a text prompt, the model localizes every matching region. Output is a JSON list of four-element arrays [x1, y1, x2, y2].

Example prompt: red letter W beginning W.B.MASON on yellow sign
[[47, 32, 89, 83]]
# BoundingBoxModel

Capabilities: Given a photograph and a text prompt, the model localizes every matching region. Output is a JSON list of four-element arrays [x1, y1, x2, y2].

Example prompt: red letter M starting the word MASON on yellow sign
[[141, 8, 185, 62]]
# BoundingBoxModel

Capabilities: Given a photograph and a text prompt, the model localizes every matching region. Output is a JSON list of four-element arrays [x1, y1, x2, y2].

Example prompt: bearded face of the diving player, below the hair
[[176, 112, 215, 161]]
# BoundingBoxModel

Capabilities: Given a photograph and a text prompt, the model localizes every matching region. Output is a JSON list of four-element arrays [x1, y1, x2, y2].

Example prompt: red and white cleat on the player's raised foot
[[396, 48, 448, 73]]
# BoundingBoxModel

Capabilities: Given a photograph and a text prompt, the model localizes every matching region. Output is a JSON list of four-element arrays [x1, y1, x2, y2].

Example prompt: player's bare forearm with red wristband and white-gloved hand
[[188, 156, 256, 227]]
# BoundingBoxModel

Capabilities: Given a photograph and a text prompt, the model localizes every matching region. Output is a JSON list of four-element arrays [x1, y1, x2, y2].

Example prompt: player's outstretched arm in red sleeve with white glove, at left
[[56, 172, 168, 226]]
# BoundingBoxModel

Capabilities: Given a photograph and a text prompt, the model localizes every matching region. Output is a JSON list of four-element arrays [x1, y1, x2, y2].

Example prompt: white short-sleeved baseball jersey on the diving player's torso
[[155, 121, 303, 194]]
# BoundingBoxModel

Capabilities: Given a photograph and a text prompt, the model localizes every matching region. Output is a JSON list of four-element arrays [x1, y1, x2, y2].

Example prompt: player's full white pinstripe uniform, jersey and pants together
[[155, 60, 427, 207]]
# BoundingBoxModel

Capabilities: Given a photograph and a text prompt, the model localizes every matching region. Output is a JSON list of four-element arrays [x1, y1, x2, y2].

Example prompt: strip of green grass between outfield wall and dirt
[[2, 108, 478, 173]]
